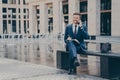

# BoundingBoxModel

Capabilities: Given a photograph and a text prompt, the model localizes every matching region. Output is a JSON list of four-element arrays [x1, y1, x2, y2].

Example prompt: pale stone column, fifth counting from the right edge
[[40, 2, 48, 34]]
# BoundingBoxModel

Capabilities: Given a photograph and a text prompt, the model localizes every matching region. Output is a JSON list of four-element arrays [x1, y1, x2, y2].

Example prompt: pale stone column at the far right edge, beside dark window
[[111, 0, 120, 36]]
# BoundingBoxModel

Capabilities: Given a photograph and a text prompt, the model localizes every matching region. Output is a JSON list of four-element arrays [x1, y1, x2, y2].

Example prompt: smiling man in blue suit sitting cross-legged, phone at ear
[[64, 13, 89, 74]]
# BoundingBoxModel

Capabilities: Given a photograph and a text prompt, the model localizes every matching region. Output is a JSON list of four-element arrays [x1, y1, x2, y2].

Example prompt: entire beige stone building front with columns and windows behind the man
[[0, 0, 120, 36]]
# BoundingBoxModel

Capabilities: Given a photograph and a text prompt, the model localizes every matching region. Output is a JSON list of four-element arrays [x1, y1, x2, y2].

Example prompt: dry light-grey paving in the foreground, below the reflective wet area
[[0, 58, 107, 80]]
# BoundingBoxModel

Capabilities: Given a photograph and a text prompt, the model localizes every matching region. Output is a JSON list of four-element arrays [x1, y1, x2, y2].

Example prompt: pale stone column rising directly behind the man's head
[[68, 0, 79, 23]]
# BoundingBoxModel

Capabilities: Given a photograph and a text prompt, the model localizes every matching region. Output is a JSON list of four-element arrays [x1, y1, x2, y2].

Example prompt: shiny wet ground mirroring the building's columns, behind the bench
[[0, 40, 106, 80]]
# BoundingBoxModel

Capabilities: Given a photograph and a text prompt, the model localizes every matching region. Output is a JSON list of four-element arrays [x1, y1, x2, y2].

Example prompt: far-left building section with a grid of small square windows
[[0, 0, 29, 34]]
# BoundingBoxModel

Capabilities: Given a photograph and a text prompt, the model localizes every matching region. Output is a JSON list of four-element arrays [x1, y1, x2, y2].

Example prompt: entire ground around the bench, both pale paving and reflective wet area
[[0, 37, 112, 80]]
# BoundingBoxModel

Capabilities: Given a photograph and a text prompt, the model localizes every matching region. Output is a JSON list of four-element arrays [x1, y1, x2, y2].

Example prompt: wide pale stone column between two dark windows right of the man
[[88, 0, 100, 35]]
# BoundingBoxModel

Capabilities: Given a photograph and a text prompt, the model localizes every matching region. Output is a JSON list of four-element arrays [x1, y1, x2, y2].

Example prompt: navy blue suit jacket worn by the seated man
[[64, 24, 89, 51]]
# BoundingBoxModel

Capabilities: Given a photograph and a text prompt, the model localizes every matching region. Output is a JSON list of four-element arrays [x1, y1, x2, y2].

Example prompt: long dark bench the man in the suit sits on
[[56, 50, 120, 79]]
